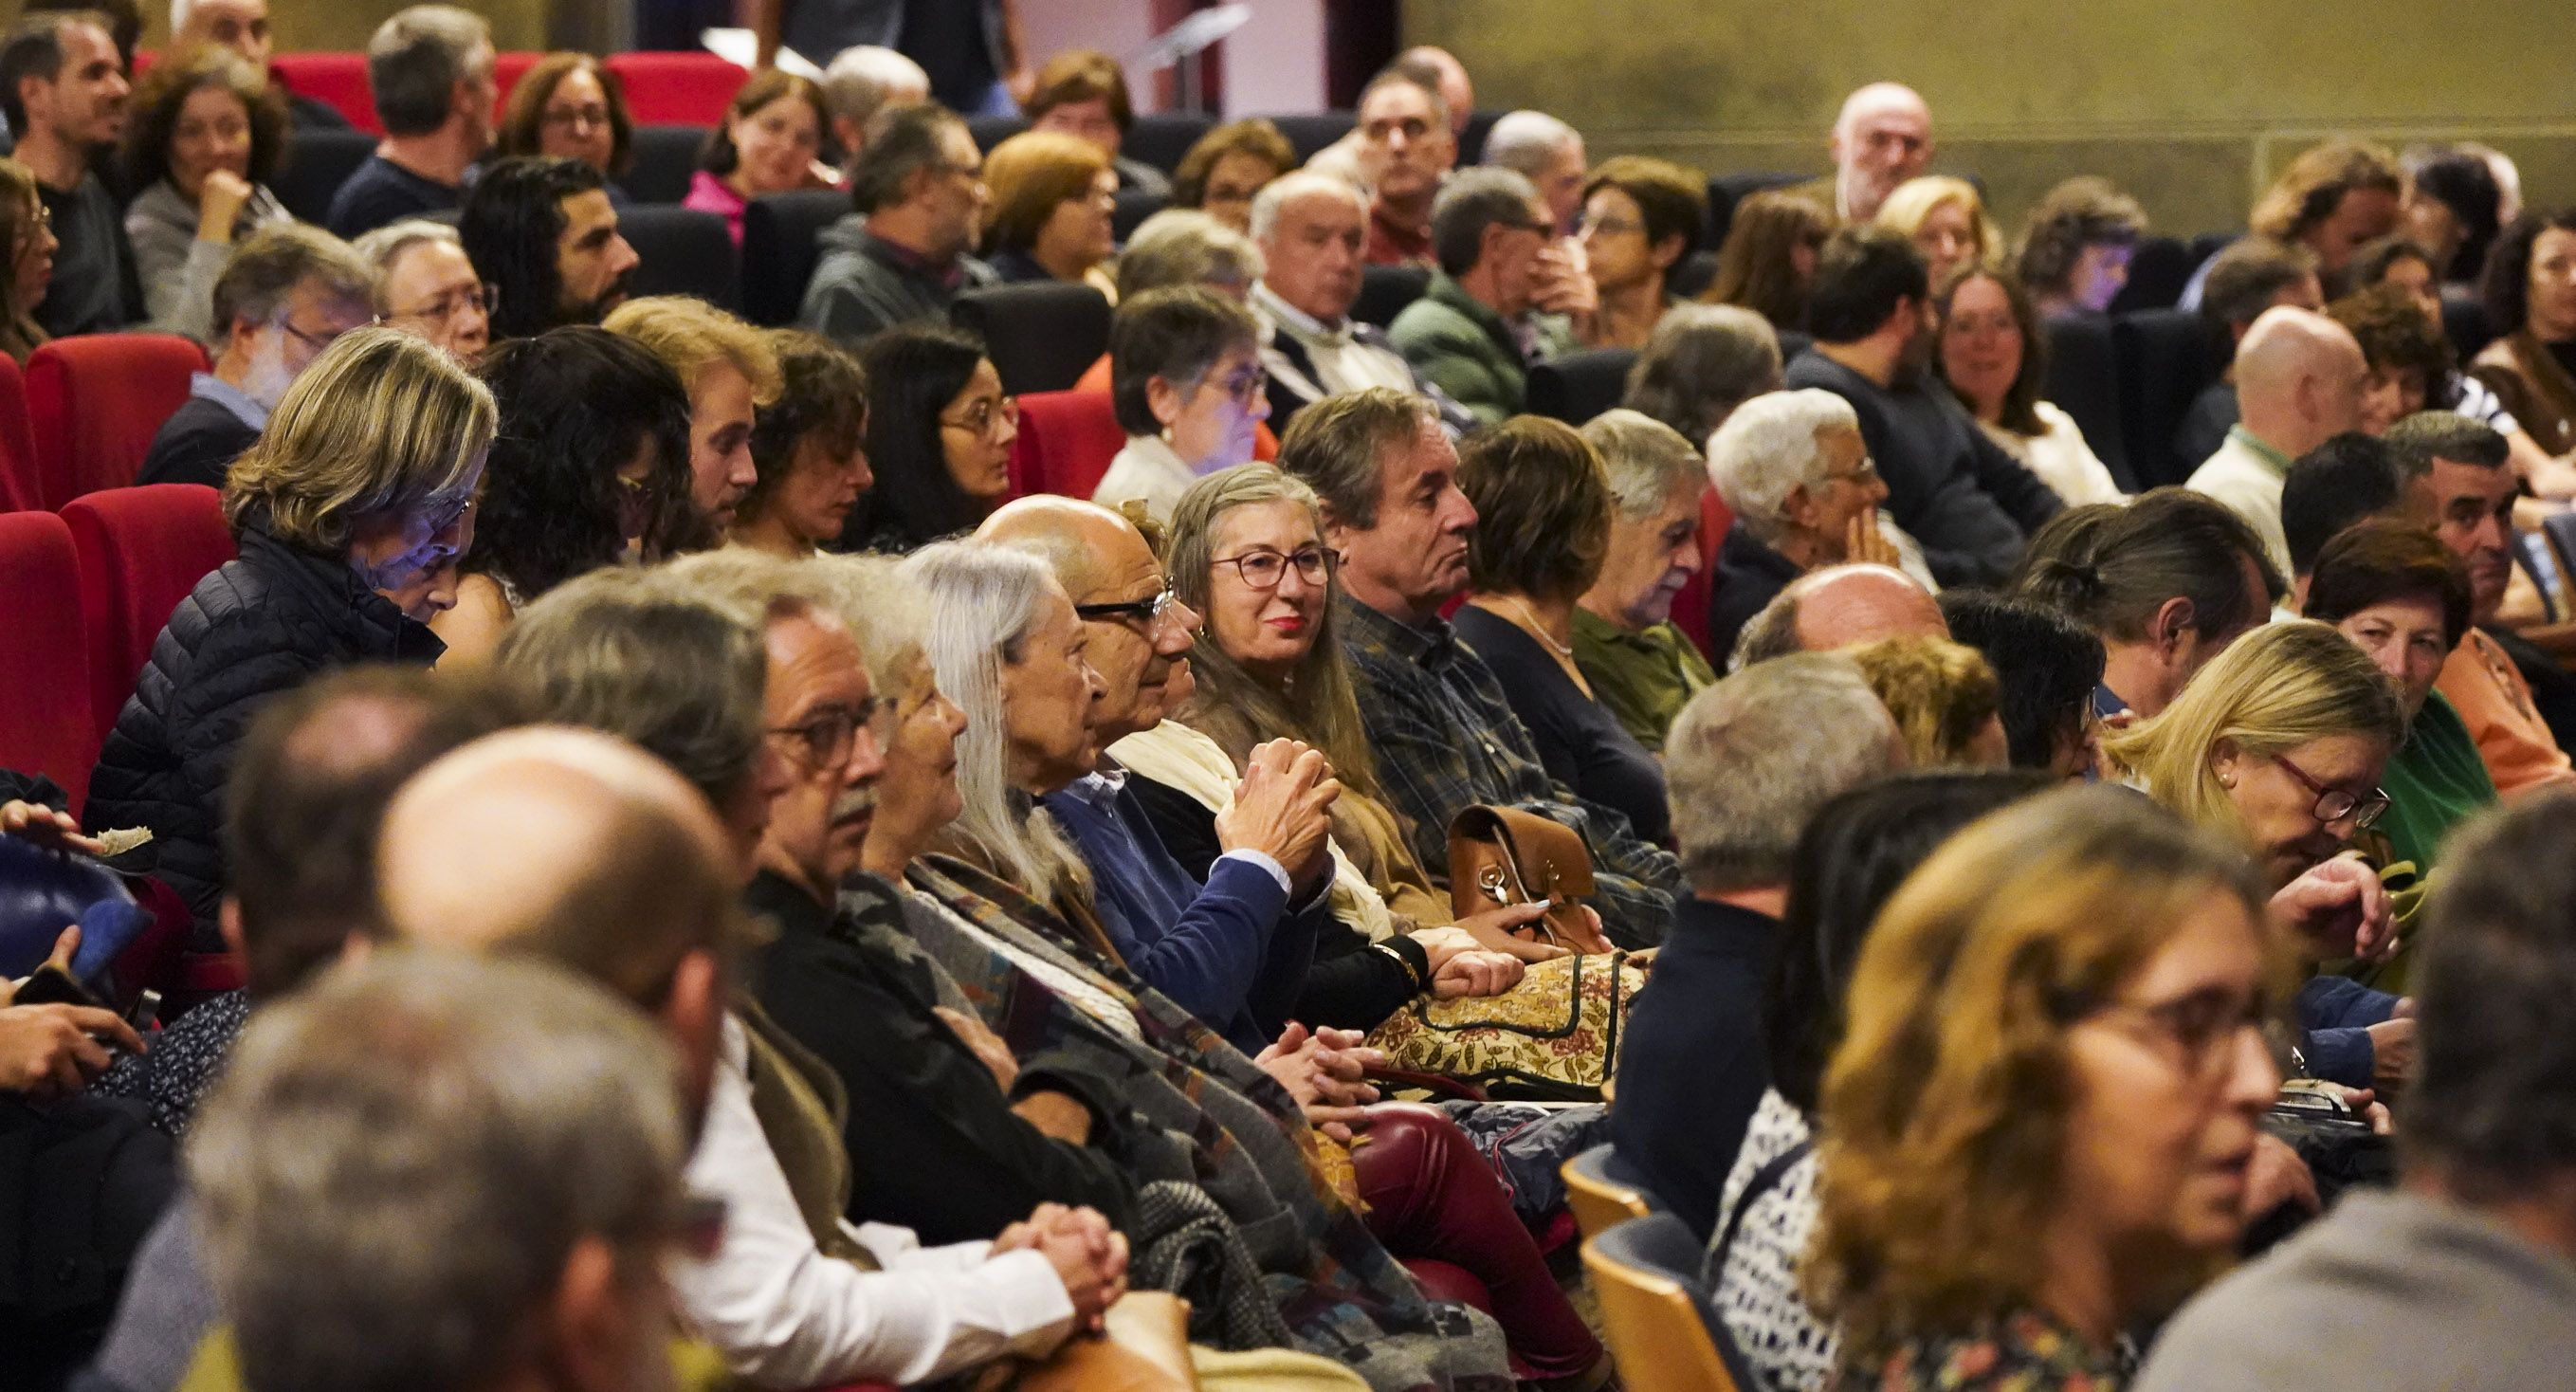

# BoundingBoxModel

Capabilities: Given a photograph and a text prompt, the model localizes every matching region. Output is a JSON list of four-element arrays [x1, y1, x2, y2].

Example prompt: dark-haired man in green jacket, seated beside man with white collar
[[1386, 168, 1574, 426]]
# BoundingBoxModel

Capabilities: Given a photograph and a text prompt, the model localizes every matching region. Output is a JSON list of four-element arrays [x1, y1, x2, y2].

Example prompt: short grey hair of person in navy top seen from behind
[[1664, 652, 1904, 894]]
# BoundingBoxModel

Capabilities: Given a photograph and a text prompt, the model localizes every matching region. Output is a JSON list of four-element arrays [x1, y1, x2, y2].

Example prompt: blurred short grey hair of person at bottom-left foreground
[[186, 951, 687, 1392]]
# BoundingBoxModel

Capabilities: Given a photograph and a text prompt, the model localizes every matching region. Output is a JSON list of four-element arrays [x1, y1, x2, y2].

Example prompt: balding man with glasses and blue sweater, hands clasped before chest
[[977, 498, 1343, 1054]]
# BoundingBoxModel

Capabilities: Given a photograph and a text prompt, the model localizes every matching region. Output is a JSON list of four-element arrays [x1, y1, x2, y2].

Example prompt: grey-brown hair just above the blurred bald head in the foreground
[[492, 567, 770, 807]]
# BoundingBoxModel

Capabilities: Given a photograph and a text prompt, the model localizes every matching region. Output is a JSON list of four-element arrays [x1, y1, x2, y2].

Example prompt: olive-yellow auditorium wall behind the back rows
[[1404, 0, 2576, 237]]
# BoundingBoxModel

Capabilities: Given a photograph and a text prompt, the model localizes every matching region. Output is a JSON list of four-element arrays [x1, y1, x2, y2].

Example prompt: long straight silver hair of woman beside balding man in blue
[[902, 541, 1087, 900]]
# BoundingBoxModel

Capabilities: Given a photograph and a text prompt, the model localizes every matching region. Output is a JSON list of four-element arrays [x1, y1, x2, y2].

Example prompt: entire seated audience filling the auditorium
[[14, 19, 2576, 1392]]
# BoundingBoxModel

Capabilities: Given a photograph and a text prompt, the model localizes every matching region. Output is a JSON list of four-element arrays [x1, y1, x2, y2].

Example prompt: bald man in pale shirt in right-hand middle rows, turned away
[[2187, 304, 2370, 575]]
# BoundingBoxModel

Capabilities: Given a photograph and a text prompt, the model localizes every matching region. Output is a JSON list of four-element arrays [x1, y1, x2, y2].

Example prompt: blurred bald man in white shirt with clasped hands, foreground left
[[378, 726, 1125, 1387]]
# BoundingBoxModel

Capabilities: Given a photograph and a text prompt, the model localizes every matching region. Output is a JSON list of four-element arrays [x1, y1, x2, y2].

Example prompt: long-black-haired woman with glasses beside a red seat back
[[840, 325, 1020, 552]]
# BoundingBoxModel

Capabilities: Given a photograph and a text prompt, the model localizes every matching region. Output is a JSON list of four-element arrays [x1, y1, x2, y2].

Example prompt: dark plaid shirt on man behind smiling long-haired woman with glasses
[[1334, 598, 1682, 948]]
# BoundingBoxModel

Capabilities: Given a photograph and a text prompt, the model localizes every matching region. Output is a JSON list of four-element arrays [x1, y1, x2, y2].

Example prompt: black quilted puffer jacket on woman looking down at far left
[[82, 518, 446, 951]]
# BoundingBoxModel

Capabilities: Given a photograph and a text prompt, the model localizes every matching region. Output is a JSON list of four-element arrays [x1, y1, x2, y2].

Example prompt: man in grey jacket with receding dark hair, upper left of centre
[[796, 105, 995, 348]]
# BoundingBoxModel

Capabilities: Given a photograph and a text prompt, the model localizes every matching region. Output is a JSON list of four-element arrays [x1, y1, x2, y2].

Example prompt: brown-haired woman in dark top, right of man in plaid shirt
[[1452, 415, 1672, 846]]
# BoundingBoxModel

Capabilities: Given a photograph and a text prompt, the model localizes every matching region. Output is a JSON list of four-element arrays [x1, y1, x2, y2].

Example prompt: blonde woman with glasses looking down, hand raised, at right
[[2102, 621, 2414, 1088]]
